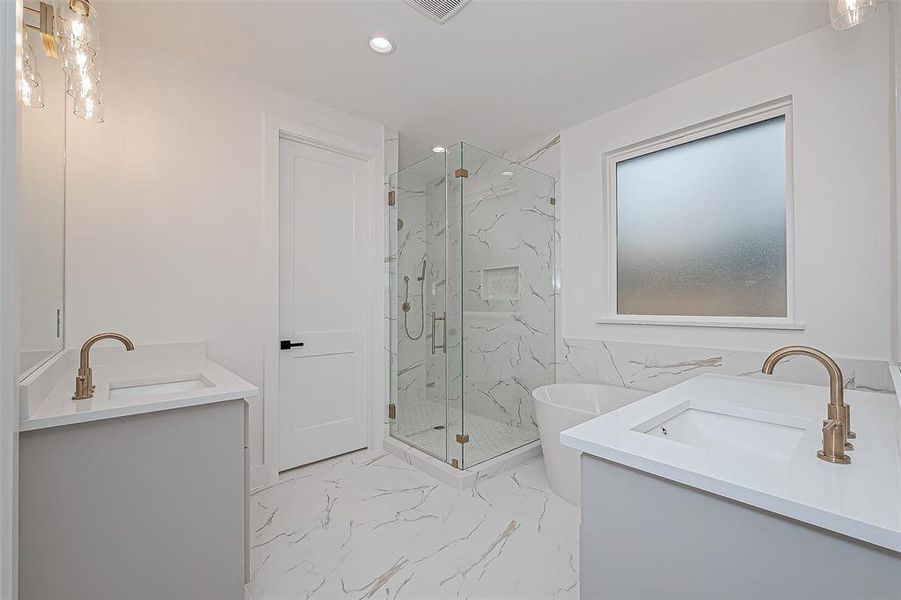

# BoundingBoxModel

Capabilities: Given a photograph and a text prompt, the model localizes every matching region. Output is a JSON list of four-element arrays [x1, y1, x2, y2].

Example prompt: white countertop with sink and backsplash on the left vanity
[[19, 343, 258, 431]]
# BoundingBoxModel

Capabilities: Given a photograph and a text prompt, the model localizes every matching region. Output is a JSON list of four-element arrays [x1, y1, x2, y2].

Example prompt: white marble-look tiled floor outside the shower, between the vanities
[[249, 451, 579, 600]]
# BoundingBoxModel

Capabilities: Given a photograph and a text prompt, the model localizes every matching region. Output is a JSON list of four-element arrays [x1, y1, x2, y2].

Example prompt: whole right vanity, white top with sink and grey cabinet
[[561, 374, 901, 600]]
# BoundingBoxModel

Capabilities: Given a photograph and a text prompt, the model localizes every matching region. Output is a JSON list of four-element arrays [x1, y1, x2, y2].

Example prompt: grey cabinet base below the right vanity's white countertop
[[580, 455, 901, 600]]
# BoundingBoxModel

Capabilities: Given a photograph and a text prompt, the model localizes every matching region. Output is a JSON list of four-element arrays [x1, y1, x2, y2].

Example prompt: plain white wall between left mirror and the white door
[[66, 30, 384, 478]]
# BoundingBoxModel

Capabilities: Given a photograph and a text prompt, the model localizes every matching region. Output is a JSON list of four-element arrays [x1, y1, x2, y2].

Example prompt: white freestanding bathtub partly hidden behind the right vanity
[[532, 383, 650, 506]]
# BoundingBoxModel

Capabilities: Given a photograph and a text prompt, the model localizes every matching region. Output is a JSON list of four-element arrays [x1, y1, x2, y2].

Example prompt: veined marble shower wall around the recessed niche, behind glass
[[463, 136, 559, 437]]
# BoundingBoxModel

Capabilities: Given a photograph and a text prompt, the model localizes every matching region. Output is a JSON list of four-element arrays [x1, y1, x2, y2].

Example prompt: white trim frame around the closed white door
[[262, 113, 388, 488]]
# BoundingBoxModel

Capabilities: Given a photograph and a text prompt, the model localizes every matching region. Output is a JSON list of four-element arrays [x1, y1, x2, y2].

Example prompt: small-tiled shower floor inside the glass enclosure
[[393, 400, 538, 469]]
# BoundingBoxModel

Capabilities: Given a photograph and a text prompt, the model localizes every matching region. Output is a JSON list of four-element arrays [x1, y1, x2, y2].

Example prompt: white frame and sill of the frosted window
[[595, 96, 804, 330]]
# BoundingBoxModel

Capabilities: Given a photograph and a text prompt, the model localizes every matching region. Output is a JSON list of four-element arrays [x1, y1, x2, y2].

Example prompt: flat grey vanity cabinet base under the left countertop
[[19, 399, 248, 600]]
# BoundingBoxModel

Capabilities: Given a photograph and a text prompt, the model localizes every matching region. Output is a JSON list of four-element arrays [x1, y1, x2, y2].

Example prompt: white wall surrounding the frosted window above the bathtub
[[560, 8, 893, 360]]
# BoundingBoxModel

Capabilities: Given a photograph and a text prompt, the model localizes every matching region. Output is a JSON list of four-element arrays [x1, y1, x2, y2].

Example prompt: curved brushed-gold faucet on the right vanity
[[761, 346, 855, 464]]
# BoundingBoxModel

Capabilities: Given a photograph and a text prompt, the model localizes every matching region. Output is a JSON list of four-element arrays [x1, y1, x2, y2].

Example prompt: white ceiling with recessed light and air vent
[[103, 0, 828, 164]]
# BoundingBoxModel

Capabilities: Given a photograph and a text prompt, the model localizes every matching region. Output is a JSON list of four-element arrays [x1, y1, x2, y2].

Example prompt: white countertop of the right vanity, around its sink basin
[[560, 374, 901, 552]]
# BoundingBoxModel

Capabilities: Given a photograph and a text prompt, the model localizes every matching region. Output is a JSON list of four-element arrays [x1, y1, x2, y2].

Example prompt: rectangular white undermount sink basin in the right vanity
[[636, 402, 807, 460]]
